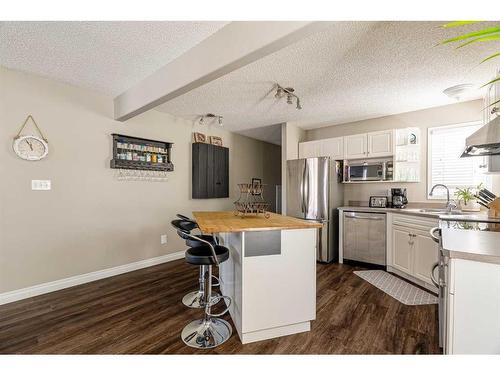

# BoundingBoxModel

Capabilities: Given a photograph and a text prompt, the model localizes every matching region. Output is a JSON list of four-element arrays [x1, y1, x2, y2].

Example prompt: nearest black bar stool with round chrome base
[[178, 229, 232, 349]]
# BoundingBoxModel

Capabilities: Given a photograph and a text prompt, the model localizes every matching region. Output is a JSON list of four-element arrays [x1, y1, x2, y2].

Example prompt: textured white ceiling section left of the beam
[[0, 22, 226, 96]]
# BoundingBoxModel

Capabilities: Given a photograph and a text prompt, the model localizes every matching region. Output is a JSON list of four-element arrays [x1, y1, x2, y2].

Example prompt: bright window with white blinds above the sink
[[427, 122, 491, 199]]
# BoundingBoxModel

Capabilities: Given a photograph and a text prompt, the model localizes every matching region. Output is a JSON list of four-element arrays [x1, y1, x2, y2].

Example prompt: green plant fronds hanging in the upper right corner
[[439, 21, 500, 106]]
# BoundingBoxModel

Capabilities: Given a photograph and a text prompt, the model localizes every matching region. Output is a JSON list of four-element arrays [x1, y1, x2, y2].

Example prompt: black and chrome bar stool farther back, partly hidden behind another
[[172, 219, 220, 309]]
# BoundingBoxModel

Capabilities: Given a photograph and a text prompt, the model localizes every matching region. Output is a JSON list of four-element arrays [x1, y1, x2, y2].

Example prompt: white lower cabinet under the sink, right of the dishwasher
[[388, 215, 439, 290]]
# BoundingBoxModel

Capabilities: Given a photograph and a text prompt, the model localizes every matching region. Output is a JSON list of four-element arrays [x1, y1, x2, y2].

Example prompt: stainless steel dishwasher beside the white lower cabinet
[[343, 211, 387, 266]]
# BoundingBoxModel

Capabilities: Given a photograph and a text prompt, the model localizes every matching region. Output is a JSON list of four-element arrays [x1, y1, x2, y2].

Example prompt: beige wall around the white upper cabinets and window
[[306, 100, 500, 204]]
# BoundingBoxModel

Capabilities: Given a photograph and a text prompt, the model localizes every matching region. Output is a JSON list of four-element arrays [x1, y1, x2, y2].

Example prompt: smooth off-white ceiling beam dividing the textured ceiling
[[114, 21, 330, 121]]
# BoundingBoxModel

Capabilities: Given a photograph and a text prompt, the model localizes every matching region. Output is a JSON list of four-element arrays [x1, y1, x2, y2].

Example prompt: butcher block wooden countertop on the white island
[[193, 211, 321, 234]]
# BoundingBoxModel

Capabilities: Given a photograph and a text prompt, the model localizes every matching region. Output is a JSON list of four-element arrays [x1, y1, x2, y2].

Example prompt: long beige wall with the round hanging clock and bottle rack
[[0, 68, 272, 293]]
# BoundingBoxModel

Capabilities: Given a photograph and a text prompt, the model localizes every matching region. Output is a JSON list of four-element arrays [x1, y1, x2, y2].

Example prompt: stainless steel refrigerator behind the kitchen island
[[285, 157, 344, 262]]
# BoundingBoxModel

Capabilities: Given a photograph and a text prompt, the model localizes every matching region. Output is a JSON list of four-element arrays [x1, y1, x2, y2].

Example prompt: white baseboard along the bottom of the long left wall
[[0, 251, 184, 305]]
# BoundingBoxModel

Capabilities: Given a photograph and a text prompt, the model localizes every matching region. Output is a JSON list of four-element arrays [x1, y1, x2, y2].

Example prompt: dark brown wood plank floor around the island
[[0, 260, 440, 354]]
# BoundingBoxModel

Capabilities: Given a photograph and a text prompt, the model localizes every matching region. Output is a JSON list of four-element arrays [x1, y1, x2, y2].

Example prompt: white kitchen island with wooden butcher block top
[[193, 211, 321, 344]]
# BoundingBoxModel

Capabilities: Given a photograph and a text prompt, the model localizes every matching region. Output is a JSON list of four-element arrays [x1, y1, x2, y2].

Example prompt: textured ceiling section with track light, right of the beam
[[157, 22, 498, 135]]
